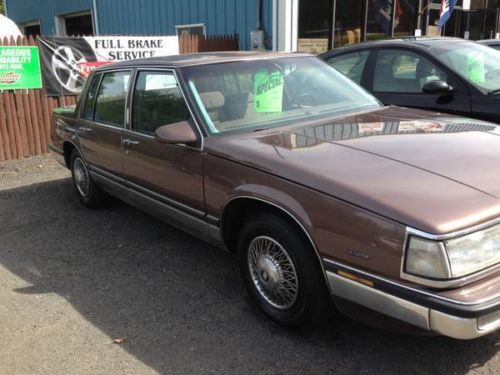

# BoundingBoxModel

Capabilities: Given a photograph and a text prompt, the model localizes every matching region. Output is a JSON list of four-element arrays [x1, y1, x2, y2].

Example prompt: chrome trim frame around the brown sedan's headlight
[[399, 225, 500, 289]]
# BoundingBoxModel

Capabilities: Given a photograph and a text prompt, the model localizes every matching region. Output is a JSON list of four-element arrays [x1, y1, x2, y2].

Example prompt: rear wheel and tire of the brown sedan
[[70, 150, 104, 208]]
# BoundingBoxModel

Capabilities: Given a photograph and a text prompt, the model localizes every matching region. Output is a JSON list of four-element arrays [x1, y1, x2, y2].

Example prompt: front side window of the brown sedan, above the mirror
[[132, 72, 190, 135]]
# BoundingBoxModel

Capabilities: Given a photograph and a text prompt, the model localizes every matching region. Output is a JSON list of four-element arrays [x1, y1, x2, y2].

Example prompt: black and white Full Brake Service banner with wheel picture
[[39, 36, 179, 96]]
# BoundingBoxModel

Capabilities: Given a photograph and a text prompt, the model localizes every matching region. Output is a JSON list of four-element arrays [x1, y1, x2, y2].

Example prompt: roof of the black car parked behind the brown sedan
[[320, 36, 471, 57]]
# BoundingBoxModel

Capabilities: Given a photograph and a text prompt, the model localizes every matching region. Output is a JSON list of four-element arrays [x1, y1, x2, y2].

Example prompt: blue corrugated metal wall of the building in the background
[[6, 0, 272, 49]]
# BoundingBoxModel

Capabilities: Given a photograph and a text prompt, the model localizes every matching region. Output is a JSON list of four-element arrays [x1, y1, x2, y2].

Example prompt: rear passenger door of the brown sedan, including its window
[[78, 70, 132, 178]]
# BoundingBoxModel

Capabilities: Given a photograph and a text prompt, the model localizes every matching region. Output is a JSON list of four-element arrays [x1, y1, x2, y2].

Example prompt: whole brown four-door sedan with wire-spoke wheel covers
[[51, 53, 500, 339]]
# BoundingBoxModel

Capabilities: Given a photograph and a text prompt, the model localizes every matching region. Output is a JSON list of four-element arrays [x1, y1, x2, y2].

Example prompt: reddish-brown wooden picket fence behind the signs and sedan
[[0, 35, 239, 161]]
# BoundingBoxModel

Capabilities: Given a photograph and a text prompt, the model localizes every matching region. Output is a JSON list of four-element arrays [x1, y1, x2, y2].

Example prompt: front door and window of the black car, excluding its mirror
[[366, 48, 470, 115]]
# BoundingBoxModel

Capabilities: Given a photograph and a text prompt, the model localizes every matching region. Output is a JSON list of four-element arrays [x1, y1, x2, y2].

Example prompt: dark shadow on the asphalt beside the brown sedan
[[0, 180, 499, 374]]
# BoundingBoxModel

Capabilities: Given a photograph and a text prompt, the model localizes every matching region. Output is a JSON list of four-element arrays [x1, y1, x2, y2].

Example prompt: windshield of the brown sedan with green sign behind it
[[183, 56, 381, 134]]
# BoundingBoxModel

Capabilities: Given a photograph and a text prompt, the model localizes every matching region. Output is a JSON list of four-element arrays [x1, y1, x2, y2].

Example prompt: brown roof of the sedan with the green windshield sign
[[95, 51, 314, 71]]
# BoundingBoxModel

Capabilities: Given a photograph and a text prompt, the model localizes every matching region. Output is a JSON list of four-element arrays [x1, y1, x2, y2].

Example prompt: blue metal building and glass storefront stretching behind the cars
[[5, 0, 500, 53]]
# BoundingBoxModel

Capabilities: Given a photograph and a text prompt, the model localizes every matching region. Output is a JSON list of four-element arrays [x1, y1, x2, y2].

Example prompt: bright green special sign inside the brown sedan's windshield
[[254, 70, 283, 112]]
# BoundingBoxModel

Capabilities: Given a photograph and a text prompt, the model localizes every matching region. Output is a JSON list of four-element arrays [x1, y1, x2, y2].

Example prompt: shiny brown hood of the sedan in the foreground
[[205, 107, 500, 234]]
